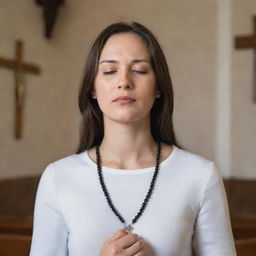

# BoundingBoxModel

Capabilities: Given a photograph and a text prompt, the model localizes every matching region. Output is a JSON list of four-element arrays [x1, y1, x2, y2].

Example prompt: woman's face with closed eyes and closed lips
[[94, 33, 158, 123]]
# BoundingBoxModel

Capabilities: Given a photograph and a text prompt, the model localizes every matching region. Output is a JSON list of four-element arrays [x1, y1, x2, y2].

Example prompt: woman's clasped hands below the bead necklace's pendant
[[100, 229, 152, 256]]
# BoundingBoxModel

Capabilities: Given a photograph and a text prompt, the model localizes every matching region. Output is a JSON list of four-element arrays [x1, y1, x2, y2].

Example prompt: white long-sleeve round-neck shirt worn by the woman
[[30, 147, 236, 256]]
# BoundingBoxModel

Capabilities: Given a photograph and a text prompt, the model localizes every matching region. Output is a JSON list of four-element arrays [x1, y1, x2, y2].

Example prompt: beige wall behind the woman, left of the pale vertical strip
[[0, 0, 253, 178]]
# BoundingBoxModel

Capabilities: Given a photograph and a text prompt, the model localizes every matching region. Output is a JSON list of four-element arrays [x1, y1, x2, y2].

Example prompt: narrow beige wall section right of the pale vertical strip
[[232, 0, 256, 178]]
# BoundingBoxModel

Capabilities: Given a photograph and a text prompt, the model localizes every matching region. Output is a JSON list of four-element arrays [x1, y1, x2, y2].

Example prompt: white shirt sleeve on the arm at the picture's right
[[193, 164, 236, 256]]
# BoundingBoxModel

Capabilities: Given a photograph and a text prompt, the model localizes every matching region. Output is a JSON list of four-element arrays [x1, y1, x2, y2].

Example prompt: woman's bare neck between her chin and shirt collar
[[100, 119, 156, 169]]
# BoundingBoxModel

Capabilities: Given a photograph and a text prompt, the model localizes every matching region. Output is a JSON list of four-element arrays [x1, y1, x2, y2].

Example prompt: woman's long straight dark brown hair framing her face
[[77, 22, 180, 154]]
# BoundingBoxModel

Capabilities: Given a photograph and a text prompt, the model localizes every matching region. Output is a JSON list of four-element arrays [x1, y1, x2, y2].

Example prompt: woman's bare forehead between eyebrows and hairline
[[100, 32, 150, 60]]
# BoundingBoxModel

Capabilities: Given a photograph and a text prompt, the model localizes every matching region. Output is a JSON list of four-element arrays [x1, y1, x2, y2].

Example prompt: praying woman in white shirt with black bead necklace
[[30, 23, 236, 256]]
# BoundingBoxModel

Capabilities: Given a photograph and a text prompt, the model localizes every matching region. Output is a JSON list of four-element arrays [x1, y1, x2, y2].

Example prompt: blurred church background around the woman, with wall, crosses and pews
[[0, 0, 256, 256]]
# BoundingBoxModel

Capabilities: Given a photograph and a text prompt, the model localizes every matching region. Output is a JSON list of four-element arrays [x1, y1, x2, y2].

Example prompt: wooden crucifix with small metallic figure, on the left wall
[[0, 41, 40, 139]]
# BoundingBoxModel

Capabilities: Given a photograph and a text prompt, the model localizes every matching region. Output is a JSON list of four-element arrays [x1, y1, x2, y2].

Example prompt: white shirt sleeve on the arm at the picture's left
[[29, 164, 68, 256]]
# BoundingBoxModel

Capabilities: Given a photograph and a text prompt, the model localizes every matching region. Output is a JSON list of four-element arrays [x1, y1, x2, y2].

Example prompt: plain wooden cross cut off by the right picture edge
[[235, 16, 256, 103]]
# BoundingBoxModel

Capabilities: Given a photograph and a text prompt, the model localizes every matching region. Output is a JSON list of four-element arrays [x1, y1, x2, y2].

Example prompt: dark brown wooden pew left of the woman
[[0, 176, 39, 256]]
